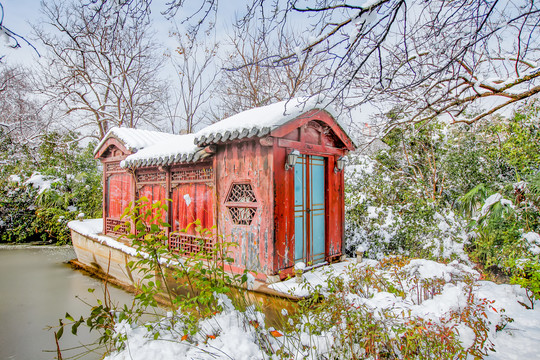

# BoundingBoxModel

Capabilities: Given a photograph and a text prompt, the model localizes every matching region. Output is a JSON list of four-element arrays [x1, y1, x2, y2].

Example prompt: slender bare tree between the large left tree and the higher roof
[[166, 32, 218, 133]]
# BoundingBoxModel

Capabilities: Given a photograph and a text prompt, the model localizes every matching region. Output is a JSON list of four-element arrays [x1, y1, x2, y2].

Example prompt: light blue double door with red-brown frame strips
[[294, 155, 326, 265]]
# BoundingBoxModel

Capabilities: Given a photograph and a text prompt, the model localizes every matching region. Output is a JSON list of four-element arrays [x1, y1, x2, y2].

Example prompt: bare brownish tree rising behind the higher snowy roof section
[[216, 20, 324, 116]]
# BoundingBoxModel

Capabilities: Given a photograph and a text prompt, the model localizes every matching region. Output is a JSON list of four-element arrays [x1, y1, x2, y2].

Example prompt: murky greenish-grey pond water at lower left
[[0, 246, 133, 360]]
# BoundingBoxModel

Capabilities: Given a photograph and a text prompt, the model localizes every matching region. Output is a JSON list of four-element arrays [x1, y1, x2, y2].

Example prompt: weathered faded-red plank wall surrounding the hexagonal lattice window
[[214, 139, 274, 278]]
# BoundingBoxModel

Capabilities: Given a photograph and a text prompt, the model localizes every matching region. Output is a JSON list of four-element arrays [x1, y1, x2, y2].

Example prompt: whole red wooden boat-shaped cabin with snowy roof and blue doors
[[95, 100, 355, 281]]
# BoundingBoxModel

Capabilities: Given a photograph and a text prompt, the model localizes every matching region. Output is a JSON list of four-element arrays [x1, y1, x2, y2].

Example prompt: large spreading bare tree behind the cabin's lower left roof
[[34, 2, 166, 138]]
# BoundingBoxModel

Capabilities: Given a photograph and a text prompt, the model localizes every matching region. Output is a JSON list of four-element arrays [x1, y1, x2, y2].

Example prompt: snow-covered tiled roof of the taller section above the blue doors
[[195, 98, 343, 146]]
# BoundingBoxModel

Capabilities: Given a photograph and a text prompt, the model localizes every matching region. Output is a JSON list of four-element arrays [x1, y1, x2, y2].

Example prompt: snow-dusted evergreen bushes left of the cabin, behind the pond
[[0, 129, 102, 243]]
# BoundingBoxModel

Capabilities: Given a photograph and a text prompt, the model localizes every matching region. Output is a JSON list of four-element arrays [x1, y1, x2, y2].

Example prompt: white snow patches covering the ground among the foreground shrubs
[[102, 259, 540, 360]]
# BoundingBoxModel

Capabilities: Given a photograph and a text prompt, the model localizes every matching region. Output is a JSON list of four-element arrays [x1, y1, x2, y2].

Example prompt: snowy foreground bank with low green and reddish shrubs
[[102, 257, 540, 360]]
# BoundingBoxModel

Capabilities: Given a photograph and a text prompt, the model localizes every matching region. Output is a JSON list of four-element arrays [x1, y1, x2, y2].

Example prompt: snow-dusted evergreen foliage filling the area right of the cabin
[[346, 102, 540, 298]]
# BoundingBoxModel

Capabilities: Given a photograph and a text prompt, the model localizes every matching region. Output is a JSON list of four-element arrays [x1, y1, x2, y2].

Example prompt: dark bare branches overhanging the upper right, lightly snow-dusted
[[80, 0, 540, 136]]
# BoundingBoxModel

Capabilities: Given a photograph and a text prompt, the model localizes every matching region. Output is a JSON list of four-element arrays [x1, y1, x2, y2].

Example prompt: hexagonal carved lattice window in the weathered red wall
[[226, 184, 257, 225]]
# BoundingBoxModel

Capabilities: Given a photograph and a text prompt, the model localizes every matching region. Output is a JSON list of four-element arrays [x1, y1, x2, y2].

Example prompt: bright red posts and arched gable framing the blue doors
[[272, 116, 352, 279]]
